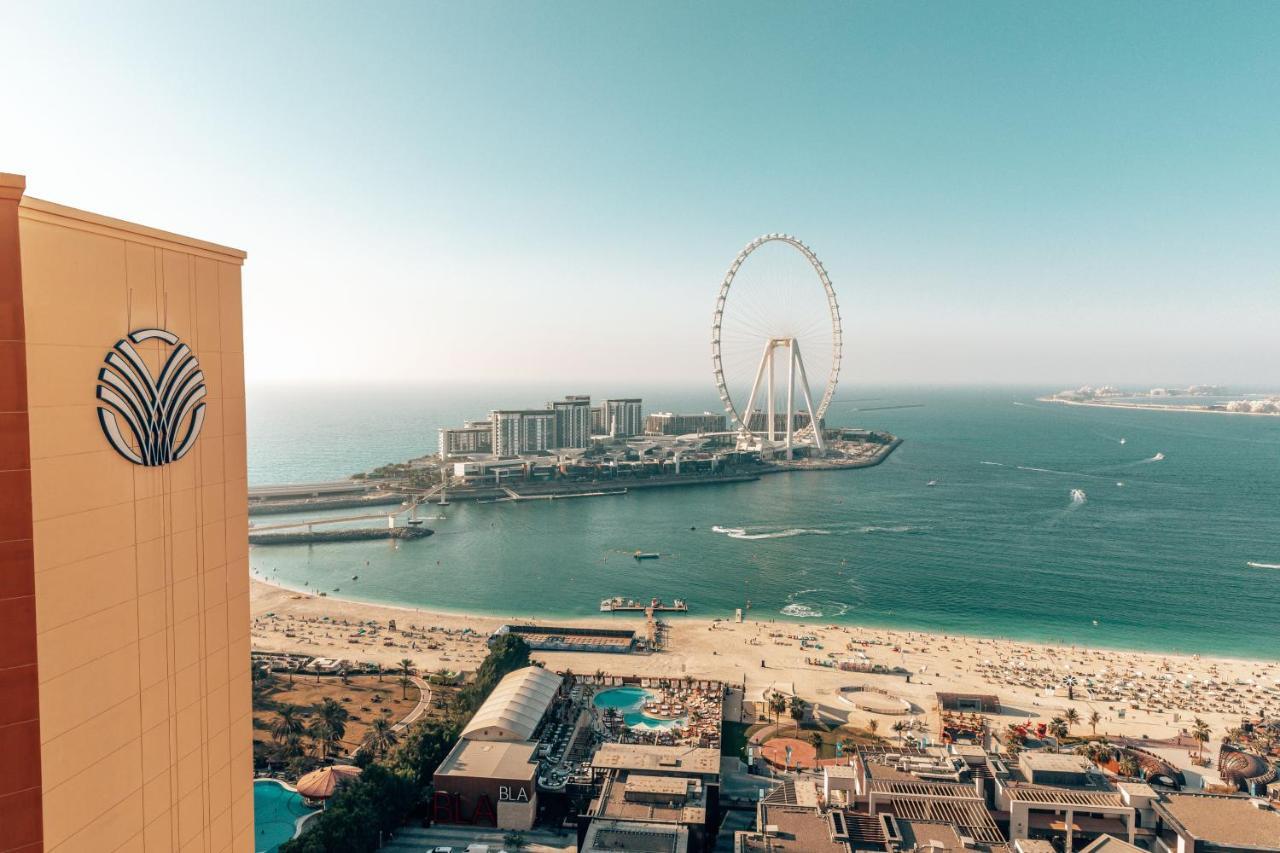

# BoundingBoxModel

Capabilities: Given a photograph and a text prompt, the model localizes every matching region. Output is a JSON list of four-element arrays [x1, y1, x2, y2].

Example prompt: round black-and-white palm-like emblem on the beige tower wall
[[97, 329, 209, 466]]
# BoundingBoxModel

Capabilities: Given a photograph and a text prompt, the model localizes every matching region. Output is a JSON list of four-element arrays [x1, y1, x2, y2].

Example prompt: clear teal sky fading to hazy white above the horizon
[[0, 0, 1280, 392]]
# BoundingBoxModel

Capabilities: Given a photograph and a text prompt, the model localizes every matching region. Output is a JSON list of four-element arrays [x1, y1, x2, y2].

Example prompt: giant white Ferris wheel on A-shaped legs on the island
[[712, 234, 842, 459]]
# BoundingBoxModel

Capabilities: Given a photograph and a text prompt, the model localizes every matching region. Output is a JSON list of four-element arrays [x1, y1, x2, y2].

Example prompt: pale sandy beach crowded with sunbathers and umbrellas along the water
[[251, 579, 1280, 742]]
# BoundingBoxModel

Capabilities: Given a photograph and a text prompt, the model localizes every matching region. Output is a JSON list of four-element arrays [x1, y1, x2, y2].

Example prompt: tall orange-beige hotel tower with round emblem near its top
[[0, 173, 253, 853]]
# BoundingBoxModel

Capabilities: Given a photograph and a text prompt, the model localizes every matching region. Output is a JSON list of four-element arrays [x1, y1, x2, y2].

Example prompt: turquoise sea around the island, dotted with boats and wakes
[[248, 387, 1280, 660]]
